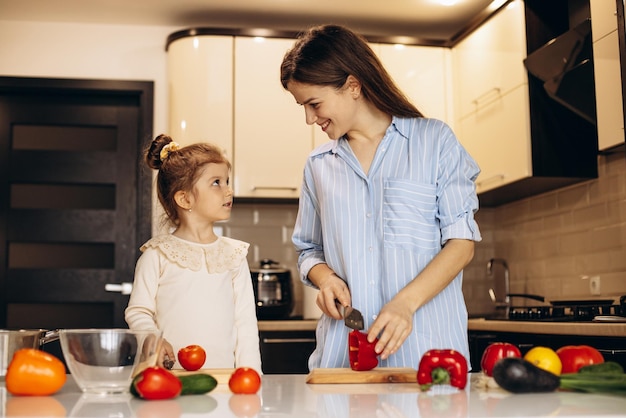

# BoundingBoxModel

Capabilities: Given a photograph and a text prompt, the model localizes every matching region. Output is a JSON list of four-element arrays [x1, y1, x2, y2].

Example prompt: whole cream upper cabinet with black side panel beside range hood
[[452, 0, 597, 206]]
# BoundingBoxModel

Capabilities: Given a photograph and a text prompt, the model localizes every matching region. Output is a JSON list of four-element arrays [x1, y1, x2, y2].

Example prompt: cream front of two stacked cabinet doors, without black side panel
[[453, 1, 532, 197]]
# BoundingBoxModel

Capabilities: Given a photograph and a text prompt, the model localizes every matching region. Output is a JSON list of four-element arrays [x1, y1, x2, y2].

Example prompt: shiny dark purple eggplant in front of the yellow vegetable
[[493, 357, 561, 393]]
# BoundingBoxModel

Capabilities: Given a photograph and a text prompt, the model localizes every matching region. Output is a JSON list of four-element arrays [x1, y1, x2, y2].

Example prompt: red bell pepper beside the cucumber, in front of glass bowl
[[130, 366, 183, 400]]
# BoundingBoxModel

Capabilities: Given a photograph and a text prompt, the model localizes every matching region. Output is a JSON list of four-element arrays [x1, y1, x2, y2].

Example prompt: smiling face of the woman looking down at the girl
[[287, 81, 357, 139]]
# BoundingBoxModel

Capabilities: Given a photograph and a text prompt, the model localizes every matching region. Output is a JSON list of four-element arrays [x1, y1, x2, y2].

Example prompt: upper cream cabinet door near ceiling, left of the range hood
[[452, 0, 528, 117]]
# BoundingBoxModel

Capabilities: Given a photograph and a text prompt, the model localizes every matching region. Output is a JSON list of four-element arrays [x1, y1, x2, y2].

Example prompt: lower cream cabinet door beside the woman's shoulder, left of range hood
[[459, 84, 532, 193]]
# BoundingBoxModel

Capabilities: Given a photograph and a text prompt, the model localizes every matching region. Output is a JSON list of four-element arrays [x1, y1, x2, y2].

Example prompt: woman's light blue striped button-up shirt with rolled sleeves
[[292, 117, 481, 370]]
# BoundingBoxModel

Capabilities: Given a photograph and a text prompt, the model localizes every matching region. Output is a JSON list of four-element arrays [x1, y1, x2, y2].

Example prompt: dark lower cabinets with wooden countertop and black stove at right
[[468, 296, 626, 372]]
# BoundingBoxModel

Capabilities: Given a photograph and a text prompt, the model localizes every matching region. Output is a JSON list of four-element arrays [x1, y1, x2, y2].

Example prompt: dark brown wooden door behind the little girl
[[0, 77, 153, 329]]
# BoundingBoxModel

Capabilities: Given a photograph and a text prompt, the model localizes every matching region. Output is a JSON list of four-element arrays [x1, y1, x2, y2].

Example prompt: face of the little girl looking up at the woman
[[189, 163, 233, 222]]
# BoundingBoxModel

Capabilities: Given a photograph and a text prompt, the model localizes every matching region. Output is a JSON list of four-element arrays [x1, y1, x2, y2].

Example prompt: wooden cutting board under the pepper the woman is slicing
[[306, 367, 417, 384]]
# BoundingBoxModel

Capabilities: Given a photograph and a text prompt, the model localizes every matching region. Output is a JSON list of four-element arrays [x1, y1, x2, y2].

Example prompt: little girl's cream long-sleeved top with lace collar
[[125, 235, 261, 372]]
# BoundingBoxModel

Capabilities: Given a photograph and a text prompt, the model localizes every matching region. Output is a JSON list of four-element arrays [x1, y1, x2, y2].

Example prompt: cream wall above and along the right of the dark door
[[0, 20, 176, 137]]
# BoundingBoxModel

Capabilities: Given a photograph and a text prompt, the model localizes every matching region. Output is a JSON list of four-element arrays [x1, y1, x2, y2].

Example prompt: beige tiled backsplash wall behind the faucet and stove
[[464, 152, 626, 314]]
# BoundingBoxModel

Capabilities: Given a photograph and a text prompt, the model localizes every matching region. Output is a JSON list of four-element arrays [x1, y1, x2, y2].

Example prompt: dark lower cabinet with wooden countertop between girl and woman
[[259, 319, 317, 374]]
